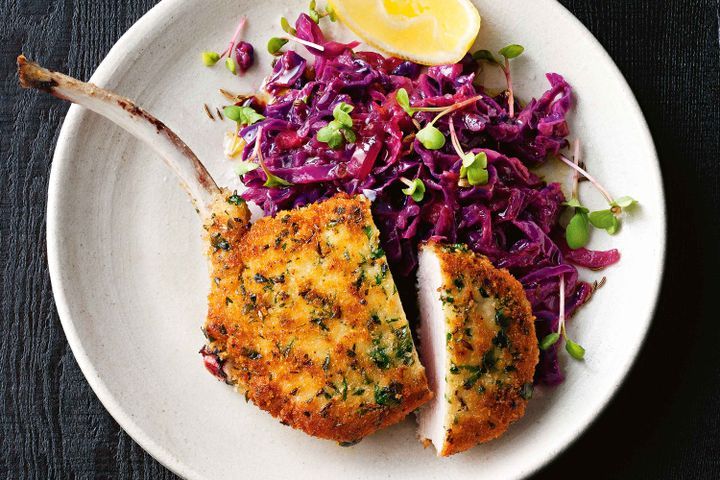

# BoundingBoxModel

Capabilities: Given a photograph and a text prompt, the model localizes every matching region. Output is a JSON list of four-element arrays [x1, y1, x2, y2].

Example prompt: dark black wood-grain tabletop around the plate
[[0, 0, 720, 479]]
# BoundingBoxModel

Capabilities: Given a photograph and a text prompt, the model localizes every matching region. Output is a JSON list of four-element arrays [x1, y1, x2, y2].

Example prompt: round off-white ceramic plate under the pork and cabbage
[[48, 0, 665, 480]]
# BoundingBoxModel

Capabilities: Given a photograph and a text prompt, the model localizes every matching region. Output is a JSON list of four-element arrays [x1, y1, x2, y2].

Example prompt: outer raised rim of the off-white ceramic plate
[[46, 0, 667, 479]]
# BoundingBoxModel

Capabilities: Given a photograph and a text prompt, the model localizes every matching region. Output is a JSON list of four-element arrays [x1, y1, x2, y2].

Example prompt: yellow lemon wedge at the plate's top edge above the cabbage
[[329, 0, 480, 65]]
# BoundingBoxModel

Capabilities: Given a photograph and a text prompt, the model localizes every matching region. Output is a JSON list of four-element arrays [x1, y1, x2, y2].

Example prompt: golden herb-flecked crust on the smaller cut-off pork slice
[[423, 242, 539, 456]]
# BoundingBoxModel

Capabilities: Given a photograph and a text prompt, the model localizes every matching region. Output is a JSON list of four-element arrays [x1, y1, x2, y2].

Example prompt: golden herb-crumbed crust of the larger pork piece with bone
[[204, 191, 432, 443]]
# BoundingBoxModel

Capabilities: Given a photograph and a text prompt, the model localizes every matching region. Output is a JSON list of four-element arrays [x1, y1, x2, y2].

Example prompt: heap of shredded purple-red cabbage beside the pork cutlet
[[240, 14, 619, 385]]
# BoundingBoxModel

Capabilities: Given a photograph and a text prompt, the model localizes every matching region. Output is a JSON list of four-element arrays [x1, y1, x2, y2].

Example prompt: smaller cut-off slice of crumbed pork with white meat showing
[[418, 242, 538, 456]]
